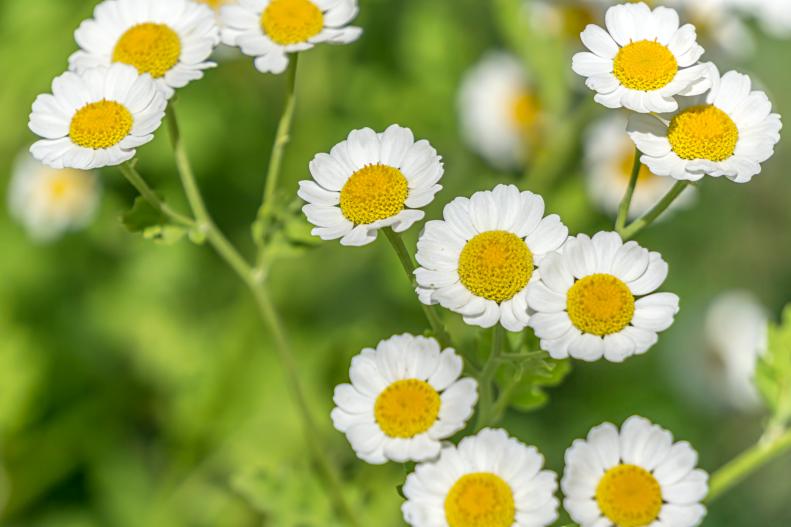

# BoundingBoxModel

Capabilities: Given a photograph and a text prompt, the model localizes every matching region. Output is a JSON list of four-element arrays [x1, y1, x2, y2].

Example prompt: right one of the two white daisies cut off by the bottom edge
[[560, 416, 708, 527]]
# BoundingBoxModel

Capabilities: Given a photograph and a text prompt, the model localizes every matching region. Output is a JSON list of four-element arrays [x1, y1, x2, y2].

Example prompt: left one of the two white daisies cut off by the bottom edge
[[401, 428, 558, 527]]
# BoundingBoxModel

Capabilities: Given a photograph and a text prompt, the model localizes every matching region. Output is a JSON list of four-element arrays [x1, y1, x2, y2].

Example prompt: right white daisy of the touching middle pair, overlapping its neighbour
[[527, 232, 678, 362]]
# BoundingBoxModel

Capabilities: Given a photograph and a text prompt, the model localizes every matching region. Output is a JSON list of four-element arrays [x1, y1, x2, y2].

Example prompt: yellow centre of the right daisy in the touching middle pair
[[566, 274, 634, 336]]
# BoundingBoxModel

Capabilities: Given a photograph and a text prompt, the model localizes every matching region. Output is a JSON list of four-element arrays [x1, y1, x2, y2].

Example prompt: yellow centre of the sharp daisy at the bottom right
[[596, 464, 662, 527]]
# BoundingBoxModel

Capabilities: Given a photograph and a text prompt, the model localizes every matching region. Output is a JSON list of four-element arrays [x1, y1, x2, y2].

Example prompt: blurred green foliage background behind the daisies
[[0, 0, 791, 527]]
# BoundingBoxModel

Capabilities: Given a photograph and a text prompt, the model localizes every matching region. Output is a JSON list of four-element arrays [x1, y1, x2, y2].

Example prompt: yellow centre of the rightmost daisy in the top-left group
[[261, 0, 324, 46]]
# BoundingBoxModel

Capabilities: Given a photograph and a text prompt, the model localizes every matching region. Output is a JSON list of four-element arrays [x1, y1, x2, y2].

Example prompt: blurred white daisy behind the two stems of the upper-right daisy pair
[[584, 113, 695, 218]]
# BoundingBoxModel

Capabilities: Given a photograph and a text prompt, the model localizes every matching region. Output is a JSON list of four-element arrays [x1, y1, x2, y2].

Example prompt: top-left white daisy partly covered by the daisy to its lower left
[[69, 0, 220, 98]]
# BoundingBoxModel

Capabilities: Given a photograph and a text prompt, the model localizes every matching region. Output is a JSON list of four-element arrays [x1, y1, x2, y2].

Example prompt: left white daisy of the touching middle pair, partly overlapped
[[415, 185, 569, 331]]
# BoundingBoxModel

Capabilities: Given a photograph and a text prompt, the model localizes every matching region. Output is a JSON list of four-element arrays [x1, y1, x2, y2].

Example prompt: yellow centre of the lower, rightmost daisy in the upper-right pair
[[667, 104, 739, 161]]
